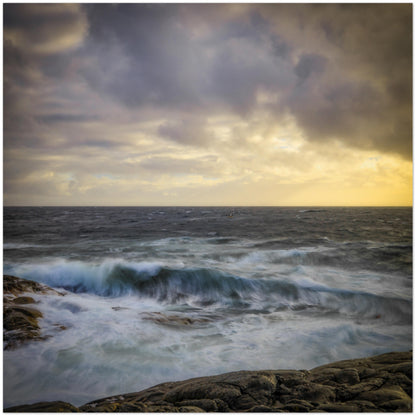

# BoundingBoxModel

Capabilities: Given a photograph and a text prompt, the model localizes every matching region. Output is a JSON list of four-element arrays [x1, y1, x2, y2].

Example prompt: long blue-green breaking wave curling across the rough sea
[[8, 260, 412, 324]]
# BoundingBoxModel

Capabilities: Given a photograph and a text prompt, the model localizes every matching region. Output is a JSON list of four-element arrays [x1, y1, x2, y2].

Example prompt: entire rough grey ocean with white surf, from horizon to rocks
[[3, 207, 412, 407]]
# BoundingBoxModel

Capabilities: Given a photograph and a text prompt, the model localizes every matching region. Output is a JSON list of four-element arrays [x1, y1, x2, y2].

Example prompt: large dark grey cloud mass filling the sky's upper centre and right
[[75, 4, 412, 158]]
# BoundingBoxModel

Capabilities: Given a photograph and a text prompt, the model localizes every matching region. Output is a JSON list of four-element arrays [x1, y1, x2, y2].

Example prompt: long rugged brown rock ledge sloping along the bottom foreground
[[5, 352, 413, 413]]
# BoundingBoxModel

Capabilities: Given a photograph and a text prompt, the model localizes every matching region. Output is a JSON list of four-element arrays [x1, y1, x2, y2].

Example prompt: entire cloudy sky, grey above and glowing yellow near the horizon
[[3, 3, 412, 206]]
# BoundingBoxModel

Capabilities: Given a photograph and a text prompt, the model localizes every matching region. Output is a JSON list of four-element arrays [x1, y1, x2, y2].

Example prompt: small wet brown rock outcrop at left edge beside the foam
[[3, 275, 63, 350]]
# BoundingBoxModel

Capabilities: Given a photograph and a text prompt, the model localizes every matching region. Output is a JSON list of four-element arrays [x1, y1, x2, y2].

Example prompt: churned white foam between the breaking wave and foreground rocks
[[4, 286, 411, 406]]
